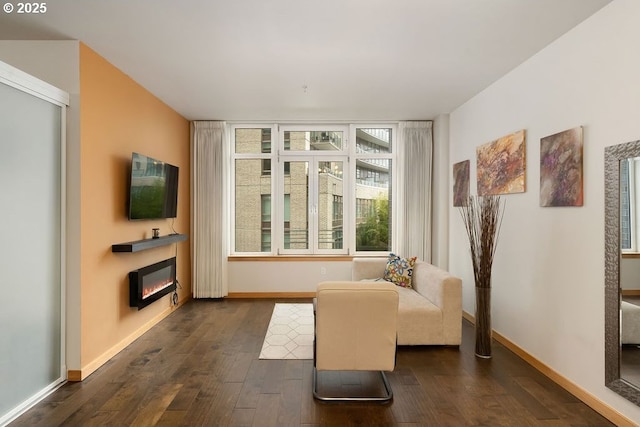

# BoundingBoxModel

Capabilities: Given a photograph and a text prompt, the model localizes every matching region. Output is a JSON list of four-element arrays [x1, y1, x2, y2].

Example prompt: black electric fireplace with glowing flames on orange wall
[[129, 257, 176, 310]]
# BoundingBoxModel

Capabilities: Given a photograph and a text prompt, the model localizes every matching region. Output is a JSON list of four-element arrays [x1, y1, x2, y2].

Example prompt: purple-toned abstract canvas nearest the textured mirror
[[540, 127, 583, 206]]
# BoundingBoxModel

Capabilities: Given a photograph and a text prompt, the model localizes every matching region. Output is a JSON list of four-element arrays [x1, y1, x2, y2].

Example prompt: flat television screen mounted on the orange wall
[[129, 153, 179, 219]]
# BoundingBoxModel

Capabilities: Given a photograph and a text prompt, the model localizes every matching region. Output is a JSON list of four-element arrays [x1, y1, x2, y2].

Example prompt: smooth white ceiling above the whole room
[[0, 0, 610, 121]]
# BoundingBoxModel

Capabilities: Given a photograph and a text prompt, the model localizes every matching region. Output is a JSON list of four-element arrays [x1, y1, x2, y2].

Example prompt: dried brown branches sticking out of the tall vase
[[460, 196, 504, 288]]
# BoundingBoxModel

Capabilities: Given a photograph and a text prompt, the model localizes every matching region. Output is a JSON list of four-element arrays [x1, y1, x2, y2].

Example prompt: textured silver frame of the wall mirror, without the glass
[[604, 141, 640, 406]]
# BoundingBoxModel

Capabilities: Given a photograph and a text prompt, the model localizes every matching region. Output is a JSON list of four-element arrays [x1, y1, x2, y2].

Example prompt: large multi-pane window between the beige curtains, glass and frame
[[230, 124, 394, 255]]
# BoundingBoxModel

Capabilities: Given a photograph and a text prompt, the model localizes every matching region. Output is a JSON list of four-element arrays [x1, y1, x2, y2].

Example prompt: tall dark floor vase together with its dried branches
[[460, 196, 504, 358]]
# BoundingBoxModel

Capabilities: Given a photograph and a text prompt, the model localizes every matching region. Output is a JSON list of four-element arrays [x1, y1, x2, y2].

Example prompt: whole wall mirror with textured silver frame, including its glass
[[605, 141, 640, 405]]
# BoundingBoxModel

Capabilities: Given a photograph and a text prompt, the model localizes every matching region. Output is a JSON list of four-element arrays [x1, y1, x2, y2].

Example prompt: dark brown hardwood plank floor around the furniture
[[10, 299, 613, 427]]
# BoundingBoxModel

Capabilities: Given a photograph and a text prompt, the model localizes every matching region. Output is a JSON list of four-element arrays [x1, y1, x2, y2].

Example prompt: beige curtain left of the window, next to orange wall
[[191, 121, 229, 298]]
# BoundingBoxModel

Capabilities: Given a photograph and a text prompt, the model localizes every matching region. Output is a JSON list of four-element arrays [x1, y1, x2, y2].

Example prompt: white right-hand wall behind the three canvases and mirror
[[449, 0, 640, 420]]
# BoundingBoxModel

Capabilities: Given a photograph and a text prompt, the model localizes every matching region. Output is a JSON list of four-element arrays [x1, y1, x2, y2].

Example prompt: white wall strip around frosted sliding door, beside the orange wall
[[0, 40, 81, 370]]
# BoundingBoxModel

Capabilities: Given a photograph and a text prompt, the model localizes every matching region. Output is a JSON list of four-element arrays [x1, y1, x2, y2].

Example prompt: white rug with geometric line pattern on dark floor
[[260, 304, 313, 359]]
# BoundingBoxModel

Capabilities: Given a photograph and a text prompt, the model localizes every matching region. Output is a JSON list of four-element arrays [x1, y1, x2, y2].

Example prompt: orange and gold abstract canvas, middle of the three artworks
[[476, 129, 526, 196]]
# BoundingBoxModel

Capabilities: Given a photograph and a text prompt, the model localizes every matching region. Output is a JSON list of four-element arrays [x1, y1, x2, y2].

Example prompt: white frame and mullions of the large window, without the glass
[[228, 122, 398, 257]]
